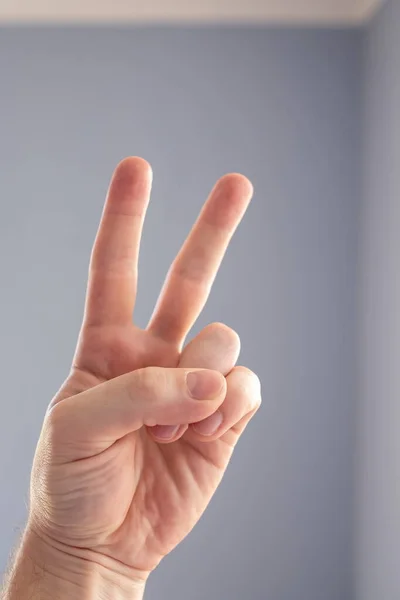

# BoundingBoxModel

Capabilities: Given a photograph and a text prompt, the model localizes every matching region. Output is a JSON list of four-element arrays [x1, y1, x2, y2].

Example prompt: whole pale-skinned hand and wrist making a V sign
[[3, 157, 261, 600]]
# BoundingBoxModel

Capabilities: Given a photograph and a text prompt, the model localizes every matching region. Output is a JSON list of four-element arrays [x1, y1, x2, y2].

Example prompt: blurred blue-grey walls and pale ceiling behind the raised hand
[[0, 0, 400, 600]]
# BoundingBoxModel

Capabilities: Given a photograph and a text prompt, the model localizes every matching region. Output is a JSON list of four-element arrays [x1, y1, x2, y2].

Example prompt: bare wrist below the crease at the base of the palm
[[4, 527, 146, 600]]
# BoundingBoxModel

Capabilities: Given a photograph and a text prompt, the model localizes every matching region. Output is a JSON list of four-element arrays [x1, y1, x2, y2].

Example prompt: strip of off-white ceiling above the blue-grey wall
[[0, 0, 384, 25]]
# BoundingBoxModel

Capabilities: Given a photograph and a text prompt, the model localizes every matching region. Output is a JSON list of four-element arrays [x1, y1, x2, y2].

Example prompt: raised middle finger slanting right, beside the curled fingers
[[148, 173, 253, 345]]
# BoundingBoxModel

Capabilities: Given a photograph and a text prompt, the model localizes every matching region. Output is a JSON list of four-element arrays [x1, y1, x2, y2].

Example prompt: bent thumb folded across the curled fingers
[[47, 367, 226, 443]]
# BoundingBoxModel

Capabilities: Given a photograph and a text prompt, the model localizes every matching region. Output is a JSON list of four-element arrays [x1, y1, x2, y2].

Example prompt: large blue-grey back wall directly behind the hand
[[0, 28, 360, 600]]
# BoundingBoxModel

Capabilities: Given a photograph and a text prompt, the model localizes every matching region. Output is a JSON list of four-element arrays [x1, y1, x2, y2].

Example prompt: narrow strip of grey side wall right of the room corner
[[356, 1, 400, 600]]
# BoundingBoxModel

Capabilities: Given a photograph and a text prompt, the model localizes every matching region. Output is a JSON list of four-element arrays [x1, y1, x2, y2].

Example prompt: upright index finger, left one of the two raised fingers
[[84, 157, 152, 325]]
